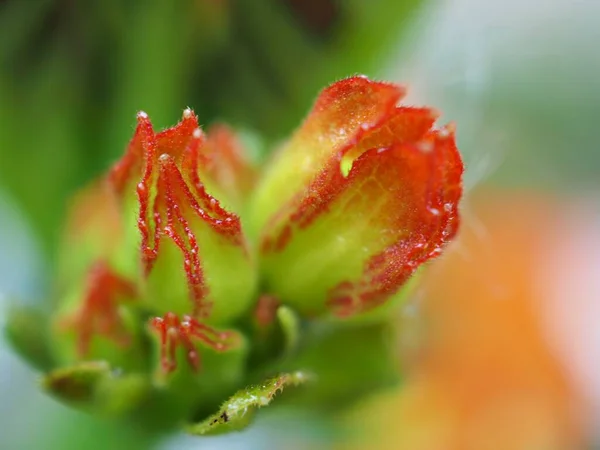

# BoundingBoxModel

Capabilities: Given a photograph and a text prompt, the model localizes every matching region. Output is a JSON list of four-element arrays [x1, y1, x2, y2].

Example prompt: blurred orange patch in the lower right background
[[343, 192, 585, 450]]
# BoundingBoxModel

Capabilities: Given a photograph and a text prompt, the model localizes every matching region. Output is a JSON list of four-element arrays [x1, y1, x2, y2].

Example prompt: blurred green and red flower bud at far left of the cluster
[[51, 180, 145, 370]]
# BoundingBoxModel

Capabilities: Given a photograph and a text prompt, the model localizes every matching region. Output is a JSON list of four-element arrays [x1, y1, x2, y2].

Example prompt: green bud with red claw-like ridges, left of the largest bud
[[111, 109, 255, 323]]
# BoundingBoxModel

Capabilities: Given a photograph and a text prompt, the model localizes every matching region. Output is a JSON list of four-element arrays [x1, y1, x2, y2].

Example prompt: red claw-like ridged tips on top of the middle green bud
[[110, 109, 243, 314]]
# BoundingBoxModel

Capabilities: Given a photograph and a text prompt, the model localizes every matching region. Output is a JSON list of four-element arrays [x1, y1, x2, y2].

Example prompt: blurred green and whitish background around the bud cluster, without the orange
[[0, 0, 600, 449]]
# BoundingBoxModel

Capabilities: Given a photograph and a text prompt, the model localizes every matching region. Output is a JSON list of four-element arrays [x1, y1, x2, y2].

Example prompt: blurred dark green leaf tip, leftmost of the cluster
[[4, 305, 53, 371]]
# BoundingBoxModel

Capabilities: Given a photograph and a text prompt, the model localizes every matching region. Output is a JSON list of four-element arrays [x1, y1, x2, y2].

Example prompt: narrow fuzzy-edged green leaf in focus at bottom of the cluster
[[187, 371, 309, 435]]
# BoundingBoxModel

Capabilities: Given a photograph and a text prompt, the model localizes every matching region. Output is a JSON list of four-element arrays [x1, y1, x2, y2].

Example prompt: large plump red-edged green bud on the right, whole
[[253, 77, 463, 316]]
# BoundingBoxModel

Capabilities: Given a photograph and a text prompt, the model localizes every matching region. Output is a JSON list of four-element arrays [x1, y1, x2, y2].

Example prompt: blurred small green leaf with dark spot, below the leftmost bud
[[42, 361, 150, 415]]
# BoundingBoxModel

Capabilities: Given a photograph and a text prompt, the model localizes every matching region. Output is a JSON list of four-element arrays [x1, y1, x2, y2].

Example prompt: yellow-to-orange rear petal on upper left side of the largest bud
[[255, 77, 405, 234]]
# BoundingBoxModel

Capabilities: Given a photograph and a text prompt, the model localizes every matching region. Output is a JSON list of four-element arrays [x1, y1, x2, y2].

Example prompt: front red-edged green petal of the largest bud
[[261, 101, 463, 315]]
